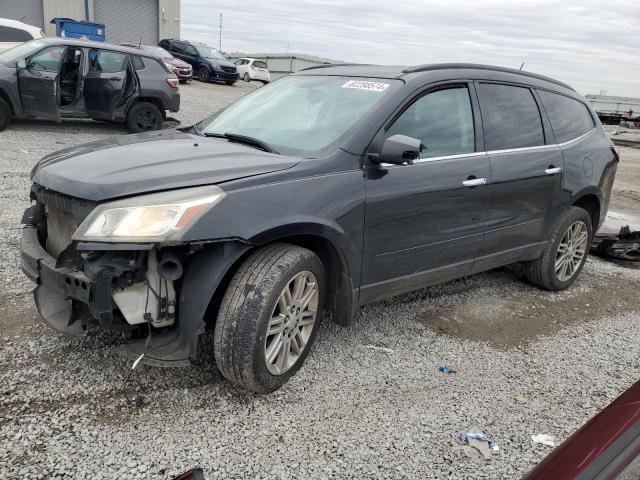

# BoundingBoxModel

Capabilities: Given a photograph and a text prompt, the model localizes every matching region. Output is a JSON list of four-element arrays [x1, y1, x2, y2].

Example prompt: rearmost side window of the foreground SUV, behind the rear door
[[538, 90, 595, 143]]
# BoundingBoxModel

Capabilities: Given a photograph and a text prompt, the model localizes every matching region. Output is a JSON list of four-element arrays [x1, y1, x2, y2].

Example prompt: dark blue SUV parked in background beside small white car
[[158, 39, 239, 85]]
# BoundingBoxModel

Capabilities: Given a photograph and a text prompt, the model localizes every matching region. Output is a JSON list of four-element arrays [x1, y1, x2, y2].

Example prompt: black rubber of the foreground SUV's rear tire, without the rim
[[525, 207, 593, 291]]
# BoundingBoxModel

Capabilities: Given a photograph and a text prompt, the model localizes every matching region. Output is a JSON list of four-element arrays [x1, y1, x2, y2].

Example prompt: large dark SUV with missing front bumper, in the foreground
[[22, 64, 618, 392]]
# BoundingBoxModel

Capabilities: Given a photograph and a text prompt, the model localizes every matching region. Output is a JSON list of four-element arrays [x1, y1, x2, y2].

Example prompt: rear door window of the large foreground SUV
[[478, 83, 544, 150]]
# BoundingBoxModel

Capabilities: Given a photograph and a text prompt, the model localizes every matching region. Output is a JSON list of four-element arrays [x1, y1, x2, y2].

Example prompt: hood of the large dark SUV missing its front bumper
[[31, 130, 301, 202]]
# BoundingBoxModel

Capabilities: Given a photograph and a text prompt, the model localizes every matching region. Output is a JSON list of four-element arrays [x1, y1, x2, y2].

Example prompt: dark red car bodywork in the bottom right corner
[[524, 382, 640, 480]]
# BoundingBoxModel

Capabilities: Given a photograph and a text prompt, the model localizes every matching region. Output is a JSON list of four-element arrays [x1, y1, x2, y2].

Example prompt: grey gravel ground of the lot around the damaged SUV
[[0, 82, 640, 479]]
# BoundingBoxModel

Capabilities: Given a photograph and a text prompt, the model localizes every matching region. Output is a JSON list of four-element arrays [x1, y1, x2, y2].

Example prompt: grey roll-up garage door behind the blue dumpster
[[95, 0, 159, 45]]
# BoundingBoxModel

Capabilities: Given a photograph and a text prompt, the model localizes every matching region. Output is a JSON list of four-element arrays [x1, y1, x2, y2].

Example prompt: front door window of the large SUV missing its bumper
[[386, 87, 475, 158]]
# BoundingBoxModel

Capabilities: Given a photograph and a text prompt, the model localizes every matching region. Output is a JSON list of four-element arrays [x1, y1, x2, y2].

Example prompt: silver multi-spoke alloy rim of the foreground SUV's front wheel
[[264, 271, 320, 375]]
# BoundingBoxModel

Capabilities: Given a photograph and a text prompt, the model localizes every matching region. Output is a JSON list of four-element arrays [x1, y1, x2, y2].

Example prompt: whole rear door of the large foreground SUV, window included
[[474, 82, 564, 271]]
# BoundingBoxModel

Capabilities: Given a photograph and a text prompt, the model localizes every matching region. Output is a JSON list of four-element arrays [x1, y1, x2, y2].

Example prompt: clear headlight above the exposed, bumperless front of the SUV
[[72, 186, 226, 242]]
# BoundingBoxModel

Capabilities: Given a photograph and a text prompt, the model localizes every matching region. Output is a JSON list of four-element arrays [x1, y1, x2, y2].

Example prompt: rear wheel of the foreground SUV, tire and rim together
[[525, 207, 593, 291]]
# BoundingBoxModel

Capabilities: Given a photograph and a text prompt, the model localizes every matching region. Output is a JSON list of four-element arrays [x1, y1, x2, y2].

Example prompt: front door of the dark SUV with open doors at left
[[18, 45, 66, 121]]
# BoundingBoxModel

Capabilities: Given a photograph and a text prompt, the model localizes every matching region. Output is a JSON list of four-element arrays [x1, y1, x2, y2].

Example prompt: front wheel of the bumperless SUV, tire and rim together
[[214, 243, 325, 393]]
